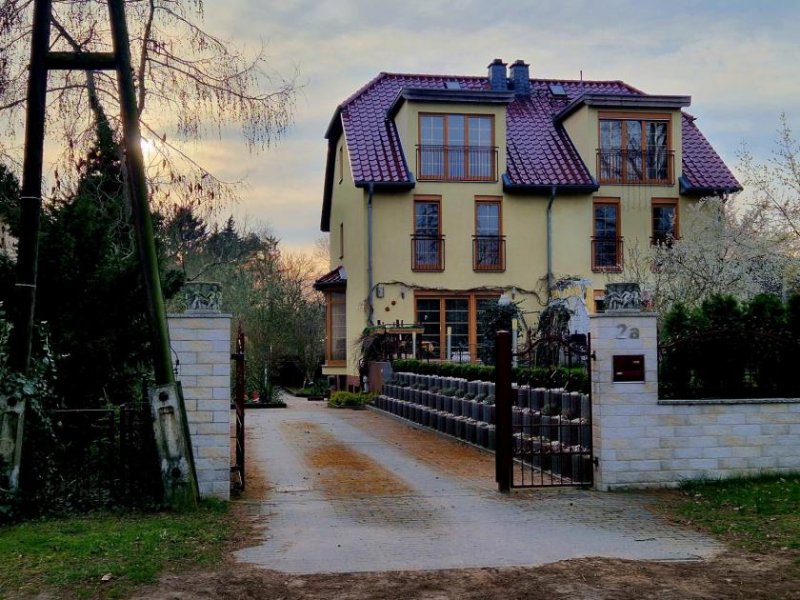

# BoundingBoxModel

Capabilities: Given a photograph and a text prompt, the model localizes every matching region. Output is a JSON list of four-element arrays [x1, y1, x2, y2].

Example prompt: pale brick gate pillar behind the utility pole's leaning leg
[[168, 312, 231, 500]]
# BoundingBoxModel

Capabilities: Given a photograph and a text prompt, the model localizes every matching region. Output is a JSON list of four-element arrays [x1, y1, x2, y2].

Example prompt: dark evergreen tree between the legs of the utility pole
[[26, 113, 181, 408]]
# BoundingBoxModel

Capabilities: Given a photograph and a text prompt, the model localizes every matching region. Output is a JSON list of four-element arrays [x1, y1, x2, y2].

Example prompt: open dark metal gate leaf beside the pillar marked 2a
[[496, 332, 594, 491]]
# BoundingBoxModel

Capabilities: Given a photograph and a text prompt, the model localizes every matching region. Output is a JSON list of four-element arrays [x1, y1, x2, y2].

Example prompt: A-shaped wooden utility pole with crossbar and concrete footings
[[7, 0, 199, 508]]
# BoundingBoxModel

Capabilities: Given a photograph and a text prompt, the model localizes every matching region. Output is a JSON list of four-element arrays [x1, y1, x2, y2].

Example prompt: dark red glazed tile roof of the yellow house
[[322, 73, 739, 231]]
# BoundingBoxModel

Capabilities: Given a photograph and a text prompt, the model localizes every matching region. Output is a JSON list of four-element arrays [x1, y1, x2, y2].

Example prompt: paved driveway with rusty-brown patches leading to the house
[[237, 397, 722, 573]]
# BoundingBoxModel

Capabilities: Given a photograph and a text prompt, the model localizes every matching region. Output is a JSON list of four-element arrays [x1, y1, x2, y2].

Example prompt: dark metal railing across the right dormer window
[[597, 148, 675, 185]]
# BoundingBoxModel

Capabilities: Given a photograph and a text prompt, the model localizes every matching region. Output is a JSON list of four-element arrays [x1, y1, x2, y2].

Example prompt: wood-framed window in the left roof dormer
[[417, 114, 497, 181]]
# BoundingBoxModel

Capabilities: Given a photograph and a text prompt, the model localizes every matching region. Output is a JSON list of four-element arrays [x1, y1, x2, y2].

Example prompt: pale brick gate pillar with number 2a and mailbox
[[590, 309, 660, 490]]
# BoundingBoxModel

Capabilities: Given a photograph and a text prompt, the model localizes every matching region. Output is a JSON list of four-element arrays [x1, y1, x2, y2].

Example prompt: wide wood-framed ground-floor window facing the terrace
[[416, 294, 499, 362]]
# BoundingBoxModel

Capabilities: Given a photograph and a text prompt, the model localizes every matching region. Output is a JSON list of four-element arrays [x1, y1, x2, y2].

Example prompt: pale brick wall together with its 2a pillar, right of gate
[[591, 311, 800, 490]]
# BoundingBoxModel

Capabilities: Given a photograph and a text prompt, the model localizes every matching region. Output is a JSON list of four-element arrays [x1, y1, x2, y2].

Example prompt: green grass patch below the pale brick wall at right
[[674, 473, 800, 553]]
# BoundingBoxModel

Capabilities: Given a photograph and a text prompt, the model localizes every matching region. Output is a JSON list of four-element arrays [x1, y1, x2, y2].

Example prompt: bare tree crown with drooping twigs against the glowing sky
[[0, 0, 295, 211]]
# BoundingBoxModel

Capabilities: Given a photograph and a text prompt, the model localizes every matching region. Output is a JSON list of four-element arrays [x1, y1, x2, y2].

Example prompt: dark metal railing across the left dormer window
[[417, 145, 497, 181]]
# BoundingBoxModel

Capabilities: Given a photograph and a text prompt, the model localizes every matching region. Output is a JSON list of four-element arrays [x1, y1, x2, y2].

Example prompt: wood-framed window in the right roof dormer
[[597, 113, 673, 184]]
